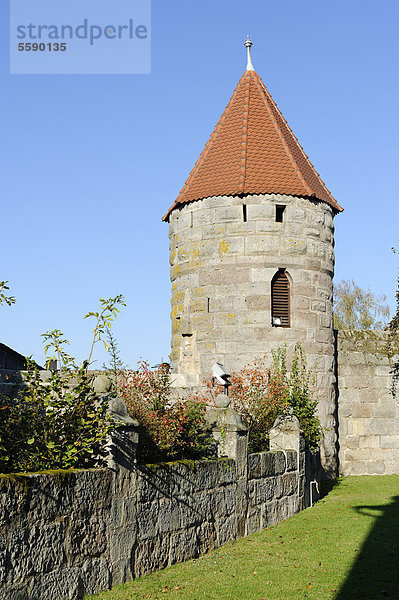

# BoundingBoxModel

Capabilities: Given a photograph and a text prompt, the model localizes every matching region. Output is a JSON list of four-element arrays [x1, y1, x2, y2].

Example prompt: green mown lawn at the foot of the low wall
[[86, 475, 399, 600]]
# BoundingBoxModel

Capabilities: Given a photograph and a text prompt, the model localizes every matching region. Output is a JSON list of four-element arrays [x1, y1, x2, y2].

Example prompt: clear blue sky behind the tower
[[0, 0, 399, 366]]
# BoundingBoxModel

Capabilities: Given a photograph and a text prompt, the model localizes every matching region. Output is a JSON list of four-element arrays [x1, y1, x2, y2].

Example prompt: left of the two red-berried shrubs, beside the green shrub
[[119, 361, 210, 462]]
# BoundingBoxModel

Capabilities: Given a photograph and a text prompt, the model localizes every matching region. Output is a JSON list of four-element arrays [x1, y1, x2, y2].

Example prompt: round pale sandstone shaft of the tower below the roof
[[169, 194, 336, 470]]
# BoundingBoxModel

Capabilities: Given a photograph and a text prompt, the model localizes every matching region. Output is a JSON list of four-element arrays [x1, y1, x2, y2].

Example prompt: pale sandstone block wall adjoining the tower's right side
[[337, 331, 399, 476]]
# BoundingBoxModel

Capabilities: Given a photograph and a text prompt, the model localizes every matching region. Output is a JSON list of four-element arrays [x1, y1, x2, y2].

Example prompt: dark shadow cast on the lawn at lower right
[[336, 496, 399, 600]]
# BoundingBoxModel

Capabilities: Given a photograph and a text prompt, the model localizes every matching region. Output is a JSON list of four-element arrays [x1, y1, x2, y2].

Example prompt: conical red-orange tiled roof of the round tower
[[164, 70, 343, 221]]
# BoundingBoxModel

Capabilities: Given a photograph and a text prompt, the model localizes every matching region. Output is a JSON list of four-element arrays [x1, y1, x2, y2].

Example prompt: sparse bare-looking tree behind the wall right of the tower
[[334, 279, 389, 330]]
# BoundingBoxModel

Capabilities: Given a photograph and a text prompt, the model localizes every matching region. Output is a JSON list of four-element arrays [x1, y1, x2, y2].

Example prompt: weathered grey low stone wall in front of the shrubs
[[0, 450, 305, 600]]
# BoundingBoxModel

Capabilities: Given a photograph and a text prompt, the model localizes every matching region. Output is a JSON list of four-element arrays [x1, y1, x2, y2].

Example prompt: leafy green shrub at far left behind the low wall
[[0, 363, 114, 473]]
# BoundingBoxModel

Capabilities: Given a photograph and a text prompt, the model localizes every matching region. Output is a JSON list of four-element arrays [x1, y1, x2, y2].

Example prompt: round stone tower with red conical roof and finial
[[164, 40, 342, 474]]
